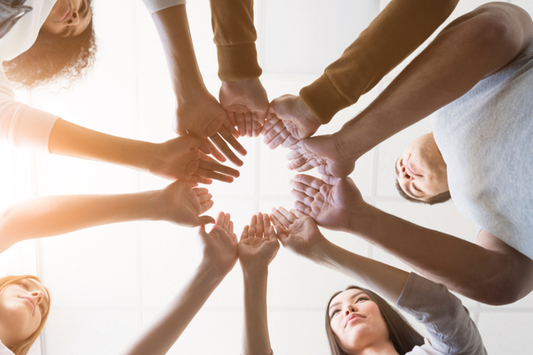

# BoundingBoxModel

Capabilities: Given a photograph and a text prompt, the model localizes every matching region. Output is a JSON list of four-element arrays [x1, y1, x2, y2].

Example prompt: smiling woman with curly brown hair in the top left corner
[[0, 0, 96, 88]]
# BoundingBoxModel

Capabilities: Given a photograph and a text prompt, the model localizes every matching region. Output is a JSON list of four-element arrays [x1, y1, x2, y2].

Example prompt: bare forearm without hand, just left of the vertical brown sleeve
[[152, 5, 207, 99]]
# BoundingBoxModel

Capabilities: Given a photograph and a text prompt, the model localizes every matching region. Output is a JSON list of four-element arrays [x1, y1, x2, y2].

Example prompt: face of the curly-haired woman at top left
[[42, 0, 92, 37]]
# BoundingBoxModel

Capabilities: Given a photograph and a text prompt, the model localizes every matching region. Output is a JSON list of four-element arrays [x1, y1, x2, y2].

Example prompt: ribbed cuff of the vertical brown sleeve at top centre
[[217, 43, 262, 81]]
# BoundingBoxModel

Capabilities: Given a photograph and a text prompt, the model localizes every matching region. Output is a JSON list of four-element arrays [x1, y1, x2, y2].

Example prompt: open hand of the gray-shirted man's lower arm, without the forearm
[[291, 174, 366, 231]]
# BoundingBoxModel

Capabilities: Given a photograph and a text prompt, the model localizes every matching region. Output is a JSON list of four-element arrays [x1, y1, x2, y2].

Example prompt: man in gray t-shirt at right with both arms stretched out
[[284, 3, 533, 305]]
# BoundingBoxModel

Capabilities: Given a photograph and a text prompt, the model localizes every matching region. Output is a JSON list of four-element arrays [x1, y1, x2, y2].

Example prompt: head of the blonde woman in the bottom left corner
[[0, 275, 50, 355]]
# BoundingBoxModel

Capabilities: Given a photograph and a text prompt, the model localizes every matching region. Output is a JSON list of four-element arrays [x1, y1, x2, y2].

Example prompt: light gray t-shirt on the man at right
[[433, 41, 533, 259]]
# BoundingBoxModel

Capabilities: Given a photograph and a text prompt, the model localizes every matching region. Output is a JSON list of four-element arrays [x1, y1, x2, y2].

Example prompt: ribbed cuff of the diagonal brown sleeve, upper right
[[300, 74, 351, 124]]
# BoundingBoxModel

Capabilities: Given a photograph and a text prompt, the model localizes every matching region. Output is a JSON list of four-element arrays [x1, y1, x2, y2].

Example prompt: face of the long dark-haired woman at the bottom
[[328, 289, 390, 353]]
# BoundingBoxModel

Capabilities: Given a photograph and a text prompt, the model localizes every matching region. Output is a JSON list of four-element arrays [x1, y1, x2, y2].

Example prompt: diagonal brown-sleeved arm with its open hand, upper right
[[262, 0, 458, 149]]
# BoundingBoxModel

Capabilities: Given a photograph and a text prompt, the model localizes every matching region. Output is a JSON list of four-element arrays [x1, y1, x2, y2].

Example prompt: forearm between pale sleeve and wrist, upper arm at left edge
[[48, 119, 156, 171]]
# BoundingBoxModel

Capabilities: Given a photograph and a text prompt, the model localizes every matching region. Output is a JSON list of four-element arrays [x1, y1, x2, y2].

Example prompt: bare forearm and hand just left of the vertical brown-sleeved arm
[[152, 5, 246, 166]]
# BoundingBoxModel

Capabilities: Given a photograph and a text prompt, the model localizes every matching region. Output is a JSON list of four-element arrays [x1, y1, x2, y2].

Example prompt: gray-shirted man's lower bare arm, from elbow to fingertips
[[291, 175, 533, 305]]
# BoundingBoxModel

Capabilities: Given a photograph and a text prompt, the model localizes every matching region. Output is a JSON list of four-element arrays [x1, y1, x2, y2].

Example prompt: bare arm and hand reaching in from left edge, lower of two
[[0, 180, 214, 252]]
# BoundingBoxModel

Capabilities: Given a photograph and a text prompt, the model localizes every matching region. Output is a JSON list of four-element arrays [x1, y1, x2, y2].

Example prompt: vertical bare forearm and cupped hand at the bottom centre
[[238, 213, 279, 355]]
